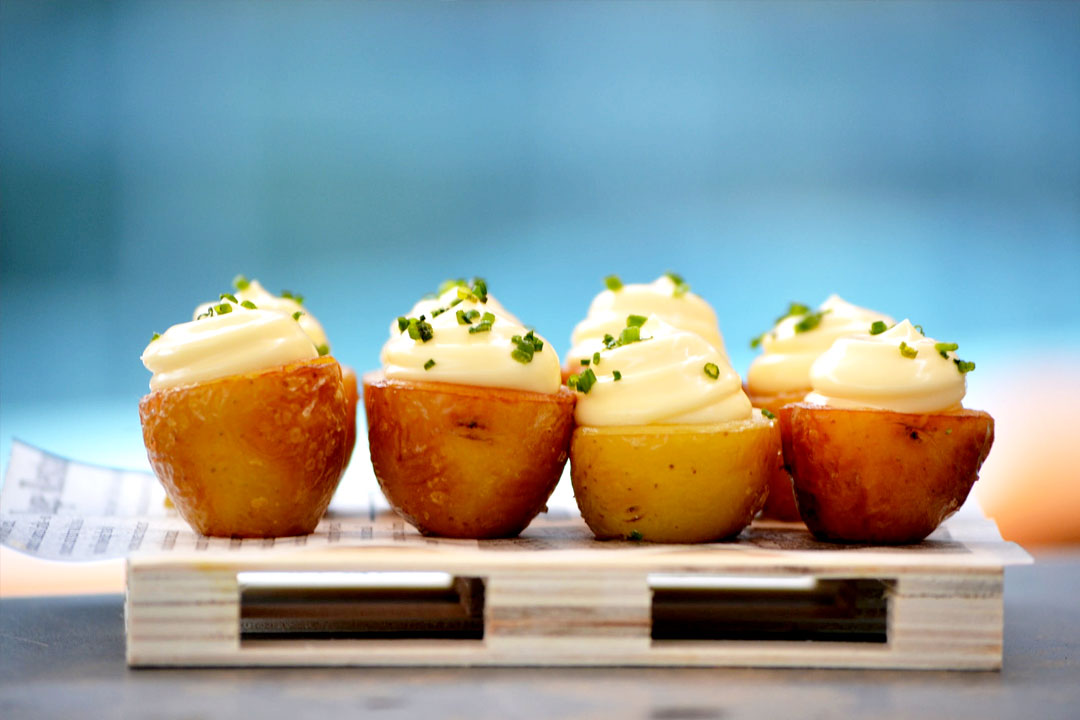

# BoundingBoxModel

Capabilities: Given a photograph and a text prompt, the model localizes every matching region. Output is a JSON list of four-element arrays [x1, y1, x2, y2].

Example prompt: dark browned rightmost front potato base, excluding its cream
[[779, 403, 994, 544]]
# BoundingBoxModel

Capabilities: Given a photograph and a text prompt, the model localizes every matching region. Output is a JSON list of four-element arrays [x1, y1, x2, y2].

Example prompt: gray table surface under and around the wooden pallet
[[0, 547, 1080, 720]]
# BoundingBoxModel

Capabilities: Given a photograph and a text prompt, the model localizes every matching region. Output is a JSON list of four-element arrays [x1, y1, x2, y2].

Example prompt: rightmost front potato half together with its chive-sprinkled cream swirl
[[780, 320, 994, 544]]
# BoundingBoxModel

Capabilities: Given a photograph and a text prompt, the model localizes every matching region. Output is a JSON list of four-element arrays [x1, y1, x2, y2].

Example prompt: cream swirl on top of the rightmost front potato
[[806, 320, 968, 412]]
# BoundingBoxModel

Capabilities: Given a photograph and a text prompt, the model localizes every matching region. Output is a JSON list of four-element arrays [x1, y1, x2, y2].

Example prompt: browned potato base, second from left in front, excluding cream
[[364, 372, 576, 539]]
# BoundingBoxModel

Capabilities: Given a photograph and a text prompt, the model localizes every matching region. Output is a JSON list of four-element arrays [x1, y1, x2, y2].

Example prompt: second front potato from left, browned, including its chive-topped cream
[[363, 280, 575, 539]]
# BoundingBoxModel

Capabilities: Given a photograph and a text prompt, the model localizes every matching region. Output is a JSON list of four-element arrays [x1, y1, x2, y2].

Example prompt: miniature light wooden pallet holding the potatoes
[[125, 509, 1030, 670]]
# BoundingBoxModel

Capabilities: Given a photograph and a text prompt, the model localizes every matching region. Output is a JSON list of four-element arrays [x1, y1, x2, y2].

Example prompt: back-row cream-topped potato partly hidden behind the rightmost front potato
[[746, 295, 893, 520]]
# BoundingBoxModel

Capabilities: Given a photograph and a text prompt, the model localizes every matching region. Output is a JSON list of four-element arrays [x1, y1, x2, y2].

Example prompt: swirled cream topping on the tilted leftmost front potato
[[143, 308, 319, 390]]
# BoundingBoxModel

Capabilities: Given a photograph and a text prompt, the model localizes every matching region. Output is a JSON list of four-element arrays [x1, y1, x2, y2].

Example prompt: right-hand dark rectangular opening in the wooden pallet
[[648, 574, 890, 644]]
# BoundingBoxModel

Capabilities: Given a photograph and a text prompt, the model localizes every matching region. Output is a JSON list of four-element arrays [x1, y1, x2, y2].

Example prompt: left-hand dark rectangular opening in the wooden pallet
[[238, 572, 484, 644]]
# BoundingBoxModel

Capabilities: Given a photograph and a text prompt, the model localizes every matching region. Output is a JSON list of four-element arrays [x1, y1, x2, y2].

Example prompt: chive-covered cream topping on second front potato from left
[[381, 288, 562, 394]]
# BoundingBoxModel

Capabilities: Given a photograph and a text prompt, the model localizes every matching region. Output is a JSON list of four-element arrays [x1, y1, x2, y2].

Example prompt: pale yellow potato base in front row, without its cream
[[570, 415, 780, 543]]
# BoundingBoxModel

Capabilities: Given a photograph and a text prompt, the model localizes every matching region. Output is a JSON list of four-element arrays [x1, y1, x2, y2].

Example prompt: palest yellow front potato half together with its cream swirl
[[568, 315, 780, 543]]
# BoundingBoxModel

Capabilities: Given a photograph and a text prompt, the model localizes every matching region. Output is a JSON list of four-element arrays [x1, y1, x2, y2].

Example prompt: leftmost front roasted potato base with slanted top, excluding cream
[[139, 356, 349, 538]]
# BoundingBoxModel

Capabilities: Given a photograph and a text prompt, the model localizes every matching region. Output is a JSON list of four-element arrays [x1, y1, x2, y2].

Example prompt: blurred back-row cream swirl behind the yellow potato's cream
[[567, 275, 727, 363]]
